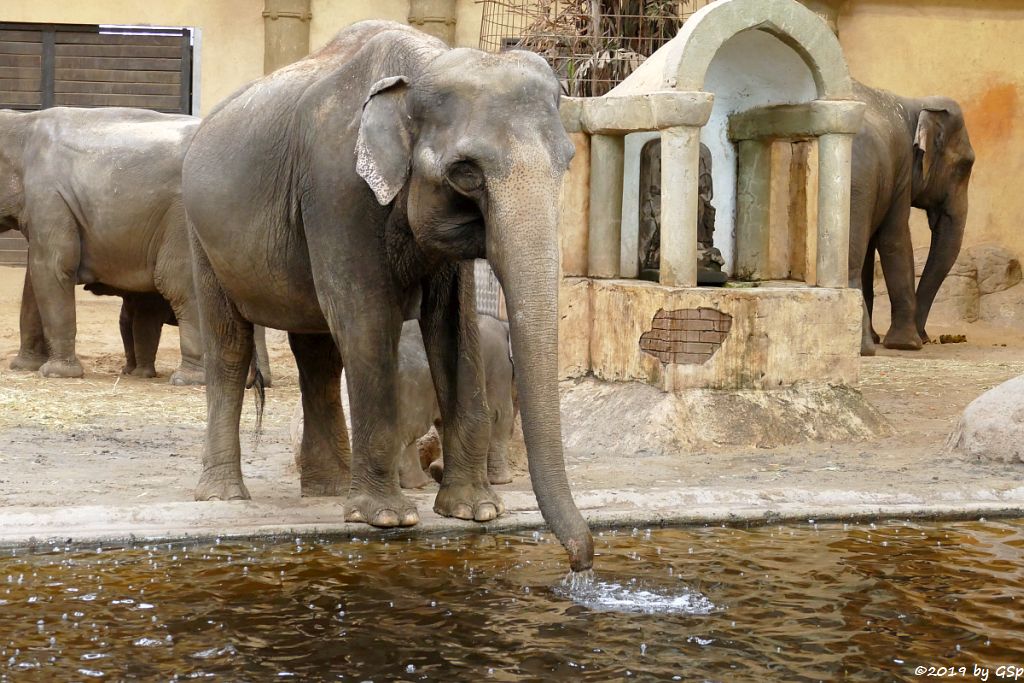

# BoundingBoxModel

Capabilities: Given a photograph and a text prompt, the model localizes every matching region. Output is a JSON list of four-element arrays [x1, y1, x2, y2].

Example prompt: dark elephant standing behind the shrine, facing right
[[850, 83, 974, 355]]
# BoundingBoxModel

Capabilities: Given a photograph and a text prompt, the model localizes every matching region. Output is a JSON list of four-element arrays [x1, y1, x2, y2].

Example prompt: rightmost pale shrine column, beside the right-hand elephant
[[816, 133, 853, 288]]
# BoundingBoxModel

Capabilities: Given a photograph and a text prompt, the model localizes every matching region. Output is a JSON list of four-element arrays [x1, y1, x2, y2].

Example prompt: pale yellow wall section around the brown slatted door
[[0, 0, 264, 114]]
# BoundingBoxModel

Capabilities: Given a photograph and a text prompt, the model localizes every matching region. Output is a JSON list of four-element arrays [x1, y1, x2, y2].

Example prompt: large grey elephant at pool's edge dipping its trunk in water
[[182, 22, 593, 569]]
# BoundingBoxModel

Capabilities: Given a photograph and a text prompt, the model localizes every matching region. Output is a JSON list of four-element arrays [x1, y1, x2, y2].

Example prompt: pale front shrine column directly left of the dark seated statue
[[659, 126, 700, 287]]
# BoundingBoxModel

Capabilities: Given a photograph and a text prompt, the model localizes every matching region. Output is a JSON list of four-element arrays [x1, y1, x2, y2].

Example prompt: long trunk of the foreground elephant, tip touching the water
[[486, 172, 594, 571]]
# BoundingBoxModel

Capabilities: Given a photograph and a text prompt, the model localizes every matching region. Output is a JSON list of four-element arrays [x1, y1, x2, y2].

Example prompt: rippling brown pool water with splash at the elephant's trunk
[[0, 520, 1024, 681]]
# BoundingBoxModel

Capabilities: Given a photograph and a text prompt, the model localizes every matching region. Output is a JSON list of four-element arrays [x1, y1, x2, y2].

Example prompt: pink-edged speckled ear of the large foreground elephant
[[355, 76, 413, 206]]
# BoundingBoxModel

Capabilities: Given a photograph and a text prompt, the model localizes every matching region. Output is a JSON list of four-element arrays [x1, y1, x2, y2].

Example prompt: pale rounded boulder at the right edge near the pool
[[946, 375, 1024, 463]]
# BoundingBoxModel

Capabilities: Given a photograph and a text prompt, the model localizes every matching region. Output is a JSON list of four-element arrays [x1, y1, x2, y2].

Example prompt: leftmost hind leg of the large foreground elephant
[[193, 236, 253, 501]]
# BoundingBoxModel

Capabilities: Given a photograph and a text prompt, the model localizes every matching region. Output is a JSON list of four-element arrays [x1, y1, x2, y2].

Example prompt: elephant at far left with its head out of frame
[[0, 106, 203, 384]]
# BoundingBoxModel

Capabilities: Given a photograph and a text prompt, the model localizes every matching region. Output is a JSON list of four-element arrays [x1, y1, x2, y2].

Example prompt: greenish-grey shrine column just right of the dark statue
[[735, 139, 770, 280]]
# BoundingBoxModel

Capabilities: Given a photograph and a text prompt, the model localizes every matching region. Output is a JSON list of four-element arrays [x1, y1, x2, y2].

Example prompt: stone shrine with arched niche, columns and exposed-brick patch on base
[[559, 0, 864, 393]]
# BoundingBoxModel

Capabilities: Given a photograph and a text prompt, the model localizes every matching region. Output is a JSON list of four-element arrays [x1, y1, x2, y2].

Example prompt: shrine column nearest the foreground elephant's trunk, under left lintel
[[587, 135, 626, 278]]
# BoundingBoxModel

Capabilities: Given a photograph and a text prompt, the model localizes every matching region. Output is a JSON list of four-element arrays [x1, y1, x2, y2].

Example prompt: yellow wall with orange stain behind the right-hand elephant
[[839, 0, 1024, 256]]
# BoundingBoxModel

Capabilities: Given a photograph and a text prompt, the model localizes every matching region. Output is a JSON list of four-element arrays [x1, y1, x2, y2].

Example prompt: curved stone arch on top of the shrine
[[663, 0, 853, 99]]
